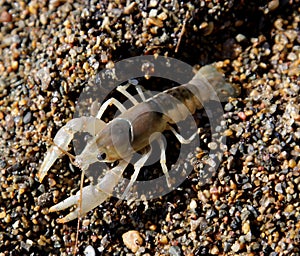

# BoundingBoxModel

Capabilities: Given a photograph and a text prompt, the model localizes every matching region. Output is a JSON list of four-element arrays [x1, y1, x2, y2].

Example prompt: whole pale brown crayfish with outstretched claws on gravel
[[38, 63, 237, 223]]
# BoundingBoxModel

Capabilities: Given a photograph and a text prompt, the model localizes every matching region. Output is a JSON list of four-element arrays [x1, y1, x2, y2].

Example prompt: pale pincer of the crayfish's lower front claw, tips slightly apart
[[49, 185, 111, 223]]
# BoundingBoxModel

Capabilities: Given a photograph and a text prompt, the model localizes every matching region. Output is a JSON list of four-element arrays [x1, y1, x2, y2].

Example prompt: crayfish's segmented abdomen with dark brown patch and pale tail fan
[[147, 65, 239, 123]]
